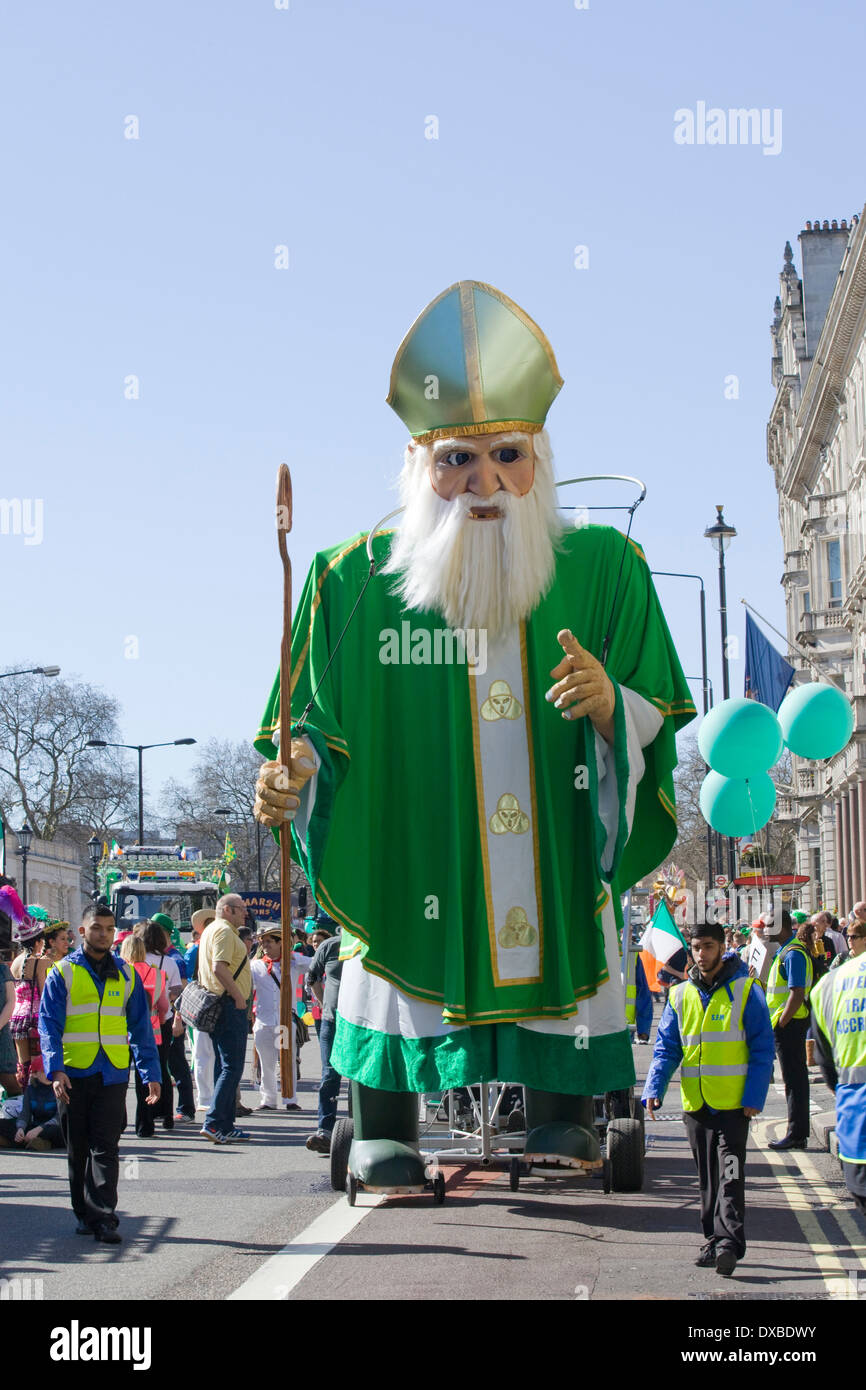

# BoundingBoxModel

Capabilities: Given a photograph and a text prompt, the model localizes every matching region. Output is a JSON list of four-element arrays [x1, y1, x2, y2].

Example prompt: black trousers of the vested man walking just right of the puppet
[[683, 1105, 749, 1259]]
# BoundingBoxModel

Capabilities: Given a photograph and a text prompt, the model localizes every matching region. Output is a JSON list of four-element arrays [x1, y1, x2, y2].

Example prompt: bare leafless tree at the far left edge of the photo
[[0, 676, 135, 840]]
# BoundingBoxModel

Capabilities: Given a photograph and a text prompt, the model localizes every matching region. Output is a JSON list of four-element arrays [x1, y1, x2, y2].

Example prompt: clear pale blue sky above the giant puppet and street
[[0, 0, 866, 811]]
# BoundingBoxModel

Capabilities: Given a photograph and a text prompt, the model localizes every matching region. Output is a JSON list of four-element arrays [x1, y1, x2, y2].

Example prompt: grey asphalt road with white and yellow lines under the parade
[[0, 1012, 866, 1302]]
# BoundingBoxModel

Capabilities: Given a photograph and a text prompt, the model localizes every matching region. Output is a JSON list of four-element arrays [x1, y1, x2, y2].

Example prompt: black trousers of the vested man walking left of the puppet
[[57, 1072, 126, 1226]]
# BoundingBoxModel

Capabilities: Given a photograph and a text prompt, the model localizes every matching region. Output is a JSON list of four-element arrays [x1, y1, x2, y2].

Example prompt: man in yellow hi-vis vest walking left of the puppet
[[39, 905, 161, 1245]]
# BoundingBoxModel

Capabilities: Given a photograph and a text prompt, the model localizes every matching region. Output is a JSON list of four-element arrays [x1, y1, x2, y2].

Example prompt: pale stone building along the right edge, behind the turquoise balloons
[[767, 205, 866, 912]]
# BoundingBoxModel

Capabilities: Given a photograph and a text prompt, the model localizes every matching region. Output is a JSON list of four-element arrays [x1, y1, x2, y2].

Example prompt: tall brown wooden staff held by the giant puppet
[[277, 463, 295, 1101]]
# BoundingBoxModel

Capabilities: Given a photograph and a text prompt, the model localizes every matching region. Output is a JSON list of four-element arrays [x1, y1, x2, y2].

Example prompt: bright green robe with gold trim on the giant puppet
[[256, 527, 695, 1088]]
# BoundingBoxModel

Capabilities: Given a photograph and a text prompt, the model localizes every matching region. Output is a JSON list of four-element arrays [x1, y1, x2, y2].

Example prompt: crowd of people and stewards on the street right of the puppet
[[638, 902, 866, 1277]]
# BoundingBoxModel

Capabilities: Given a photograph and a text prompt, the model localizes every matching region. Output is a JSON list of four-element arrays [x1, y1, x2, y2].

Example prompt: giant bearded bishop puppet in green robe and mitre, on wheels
[[256, 281, 695, 1186]]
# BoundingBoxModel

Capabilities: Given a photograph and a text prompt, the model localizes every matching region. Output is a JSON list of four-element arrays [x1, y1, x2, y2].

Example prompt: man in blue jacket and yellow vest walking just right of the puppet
[[642, 923, 774, 1279]]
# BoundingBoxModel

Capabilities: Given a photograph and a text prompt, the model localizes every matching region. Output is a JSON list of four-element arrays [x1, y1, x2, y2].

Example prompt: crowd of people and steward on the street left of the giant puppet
[[0, 894, 341, 1244]]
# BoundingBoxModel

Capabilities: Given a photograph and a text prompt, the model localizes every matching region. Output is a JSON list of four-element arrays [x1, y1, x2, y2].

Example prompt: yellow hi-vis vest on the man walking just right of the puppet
[[669, 976, 755, 1111]]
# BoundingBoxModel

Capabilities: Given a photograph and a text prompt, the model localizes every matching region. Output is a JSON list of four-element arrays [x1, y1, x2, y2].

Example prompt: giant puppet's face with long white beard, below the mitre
[[384, 431, 562, 639]]
